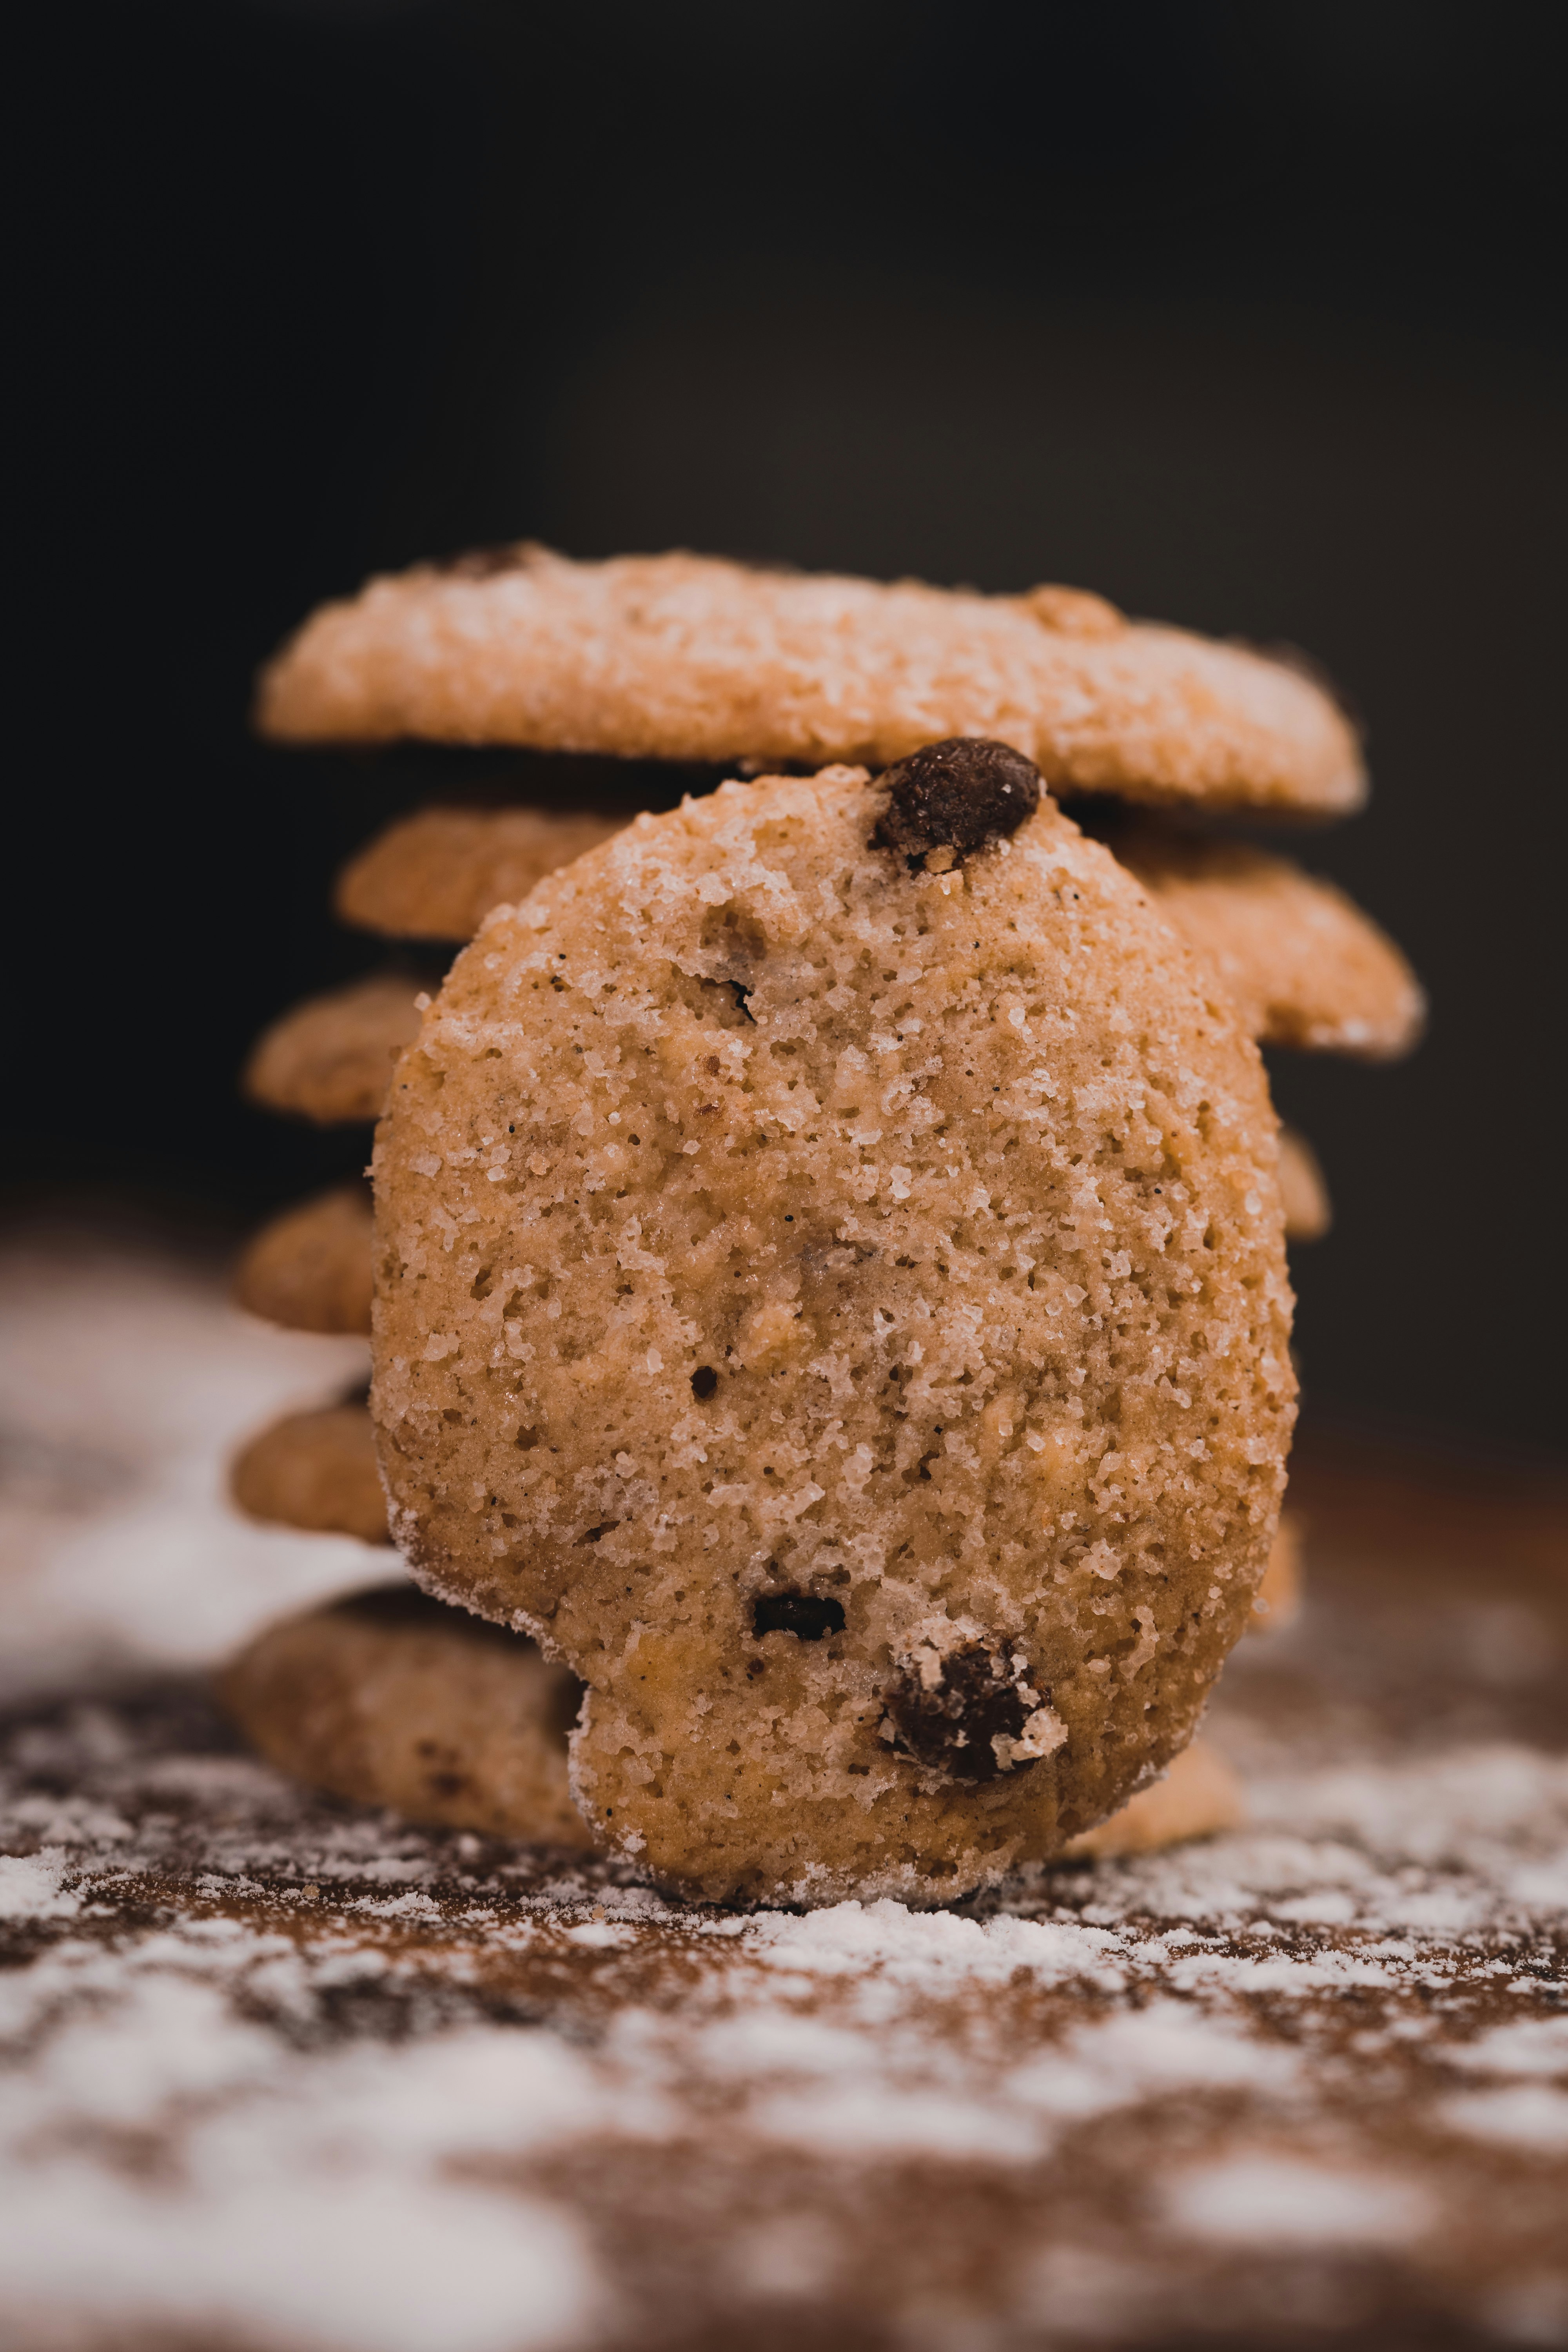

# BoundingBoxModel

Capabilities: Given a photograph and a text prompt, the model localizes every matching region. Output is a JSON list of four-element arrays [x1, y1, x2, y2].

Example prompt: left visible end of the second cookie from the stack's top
[[334, 809, 625, 938]]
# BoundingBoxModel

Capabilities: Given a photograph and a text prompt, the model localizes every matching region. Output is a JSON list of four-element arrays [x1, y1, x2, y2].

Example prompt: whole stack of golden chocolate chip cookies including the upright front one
[[228, 546, 1422, 1903]]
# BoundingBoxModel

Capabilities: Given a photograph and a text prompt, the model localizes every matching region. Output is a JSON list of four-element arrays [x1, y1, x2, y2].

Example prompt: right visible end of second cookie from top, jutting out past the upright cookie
[[1112, 826, 1427, 1061]]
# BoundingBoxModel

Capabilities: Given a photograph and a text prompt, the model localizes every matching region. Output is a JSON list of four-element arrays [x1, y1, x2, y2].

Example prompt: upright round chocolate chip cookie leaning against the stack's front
[[374, 743, 1293, 1903]]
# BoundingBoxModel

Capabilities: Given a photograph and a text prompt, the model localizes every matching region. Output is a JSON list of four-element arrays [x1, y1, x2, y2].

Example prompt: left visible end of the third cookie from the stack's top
[[240, 971, 421, 1127]]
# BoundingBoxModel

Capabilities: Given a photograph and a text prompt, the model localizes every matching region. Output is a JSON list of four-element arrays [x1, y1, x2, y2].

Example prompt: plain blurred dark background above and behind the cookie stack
[[5, 0, 1568, 1446]]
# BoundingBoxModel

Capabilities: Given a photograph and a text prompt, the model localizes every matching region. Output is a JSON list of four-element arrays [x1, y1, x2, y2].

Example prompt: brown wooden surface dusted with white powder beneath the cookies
[[0, 1223, 1568, 2352]]
